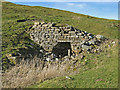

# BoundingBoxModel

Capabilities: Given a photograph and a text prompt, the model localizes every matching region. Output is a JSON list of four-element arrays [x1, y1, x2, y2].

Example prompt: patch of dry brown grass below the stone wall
[[2, 57, 76, 88]]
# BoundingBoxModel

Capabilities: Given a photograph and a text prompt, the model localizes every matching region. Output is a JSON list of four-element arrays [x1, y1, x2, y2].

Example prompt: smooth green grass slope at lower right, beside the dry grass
[[29, 41, 118, 88]]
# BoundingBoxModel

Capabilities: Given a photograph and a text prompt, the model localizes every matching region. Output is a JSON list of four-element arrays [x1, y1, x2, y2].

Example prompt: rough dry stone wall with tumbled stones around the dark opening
[[29, 22, 105, 55]]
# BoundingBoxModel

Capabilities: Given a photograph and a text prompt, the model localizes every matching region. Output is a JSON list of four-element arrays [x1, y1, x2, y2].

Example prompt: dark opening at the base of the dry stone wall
[[52, 42, 72, 58]]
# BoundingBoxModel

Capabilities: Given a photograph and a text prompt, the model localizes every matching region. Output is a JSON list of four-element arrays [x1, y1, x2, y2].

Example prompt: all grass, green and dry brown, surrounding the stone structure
[[2, 2, 118, 88]]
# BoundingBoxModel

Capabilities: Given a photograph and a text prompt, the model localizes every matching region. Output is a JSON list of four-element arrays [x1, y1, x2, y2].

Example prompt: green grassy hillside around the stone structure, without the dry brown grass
[[2, 2, 118, 88]]
